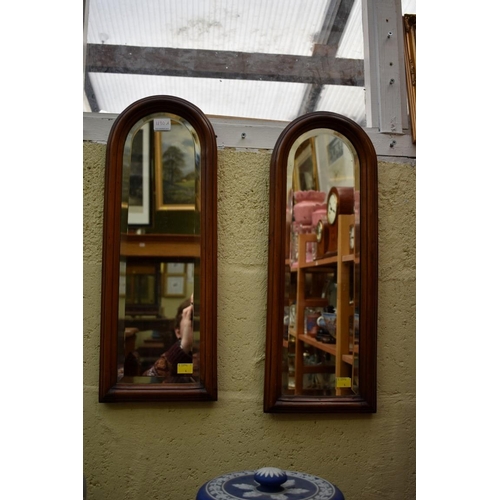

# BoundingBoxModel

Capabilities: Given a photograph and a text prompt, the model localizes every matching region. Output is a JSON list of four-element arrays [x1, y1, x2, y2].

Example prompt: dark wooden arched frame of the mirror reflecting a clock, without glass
[[264, 111, 378, 413]]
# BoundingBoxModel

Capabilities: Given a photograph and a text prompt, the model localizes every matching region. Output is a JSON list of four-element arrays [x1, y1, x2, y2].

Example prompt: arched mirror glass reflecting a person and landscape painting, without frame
[[118, 113, 201, 383]]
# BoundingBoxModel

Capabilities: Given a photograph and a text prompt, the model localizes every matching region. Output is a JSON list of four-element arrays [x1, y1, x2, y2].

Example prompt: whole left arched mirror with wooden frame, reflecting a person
[[99, 96, 217, 402]]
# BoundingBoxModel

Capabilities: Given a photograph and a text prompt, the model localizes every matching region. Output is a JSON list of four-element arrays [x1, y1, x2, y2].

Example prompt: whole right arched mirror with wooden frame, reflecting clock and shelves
[[264, 112, 378, 413]]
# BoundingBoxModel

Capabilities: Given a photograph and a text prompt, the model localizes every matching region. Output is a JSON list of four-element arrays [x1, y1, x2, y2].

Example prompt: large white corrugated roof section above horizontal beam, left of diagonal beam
[[88, 0, 328, 55]]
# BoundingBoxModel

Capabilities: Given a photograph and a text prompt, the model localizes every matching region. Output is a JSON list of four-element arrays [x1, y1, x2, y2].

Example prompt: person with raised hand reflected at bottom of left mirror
[[143, 295, 195, 383]]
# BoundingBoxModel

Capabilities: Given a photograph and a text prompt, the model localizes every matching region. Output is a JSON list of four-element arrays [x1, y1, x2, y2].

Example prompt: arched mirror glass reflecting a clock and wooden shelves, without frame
[[283, 129, 359, 396]]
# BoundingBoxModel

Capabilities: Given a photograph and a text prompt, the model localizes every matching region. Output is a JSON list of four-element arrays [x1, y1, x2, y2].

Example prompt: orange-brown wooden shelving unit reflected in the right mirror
[[284, 215, 359, 396]]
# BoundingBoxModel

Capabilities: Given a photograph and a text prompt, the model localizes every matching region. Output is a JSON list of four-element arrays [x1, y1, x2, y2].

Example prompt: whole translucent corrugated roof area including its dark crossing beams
[[84, 0, 415, 125]]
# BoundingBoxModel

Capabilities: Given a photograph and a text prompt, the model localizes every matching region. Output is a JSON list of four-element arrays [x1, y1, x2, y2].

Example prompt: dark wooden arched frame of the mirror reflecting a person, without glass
[[99, 95, 217, 402]]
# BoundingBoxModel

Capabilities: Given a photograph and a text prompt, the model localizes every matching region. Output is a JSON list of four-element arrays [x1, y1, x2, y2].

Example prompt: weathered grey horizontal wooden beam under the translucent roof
[[87, 43, 364, 87]]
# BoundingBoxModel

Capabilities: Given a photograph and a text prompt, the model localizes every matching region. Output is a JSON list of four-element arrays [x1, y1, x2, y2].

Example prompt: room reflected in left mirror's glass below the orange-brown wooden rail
[[118, 258, 200, 383]]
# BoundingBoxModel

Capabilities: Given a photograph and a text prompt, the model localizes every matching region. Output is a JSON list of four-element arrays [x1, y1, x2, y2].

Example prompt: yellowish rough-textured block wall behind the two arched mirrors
[[83, 143, 416, 500]]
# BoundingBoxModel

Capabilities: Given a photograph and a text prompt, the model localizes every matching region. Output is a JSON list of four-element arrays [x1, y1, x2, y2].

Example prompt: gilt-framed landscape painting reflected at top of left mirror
[[154, 119, 200, 210]]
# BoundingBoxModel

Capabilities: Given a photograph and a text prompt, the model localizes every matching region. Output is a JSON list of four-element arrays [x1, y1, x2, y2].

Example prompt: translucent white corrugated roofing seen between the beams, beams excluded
[[88, 0, 416, 125]]
